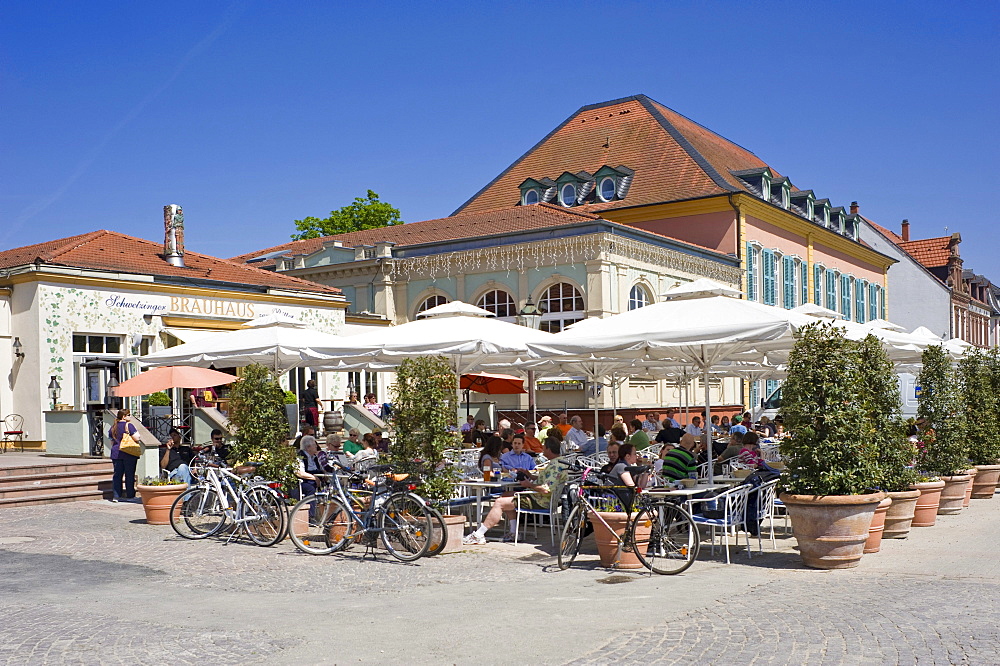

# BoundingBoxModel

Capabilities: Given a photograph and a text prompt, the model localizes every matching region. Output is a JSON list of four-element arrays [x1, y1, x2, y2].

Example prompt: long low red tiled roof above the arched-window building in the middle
[[232, 204, 600, 266]]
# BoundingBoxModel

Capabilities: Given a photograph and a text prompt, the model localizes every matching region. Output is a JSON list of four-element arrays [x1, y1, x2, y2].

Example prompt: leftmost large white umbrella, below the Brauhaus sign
[[139, 318, 376, 375]]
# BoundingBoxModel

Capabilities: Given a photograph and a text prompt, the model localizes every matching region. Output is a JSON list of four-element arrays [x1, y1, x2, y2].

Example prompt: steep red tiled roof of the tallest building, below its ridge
[[456, 95, 779, 212]]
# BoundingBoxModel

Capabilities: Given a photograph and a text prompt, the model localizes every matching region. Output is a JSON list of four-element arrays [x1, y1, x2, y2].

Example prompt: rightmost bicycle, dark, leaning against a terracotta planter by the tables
[[558, 468, 701, 575]]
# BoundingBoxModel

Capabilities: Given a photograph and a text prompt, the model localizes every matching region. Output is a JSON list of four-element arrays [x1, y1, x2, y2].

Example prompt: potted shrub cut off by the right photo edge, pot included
[[958, 347, 1000, 499]]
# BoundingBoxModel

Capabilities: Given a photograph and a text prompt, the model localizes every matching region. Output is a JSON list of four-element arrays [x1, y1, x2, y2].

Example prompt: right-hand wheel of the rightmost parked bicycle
[[629, 504, 701, 575]]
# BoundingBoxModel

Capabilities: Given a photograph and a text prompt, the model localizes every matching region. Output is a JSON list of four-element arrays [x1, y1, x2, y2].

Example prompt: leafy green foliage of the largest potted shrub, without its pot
[[781, 323, 880, 495]]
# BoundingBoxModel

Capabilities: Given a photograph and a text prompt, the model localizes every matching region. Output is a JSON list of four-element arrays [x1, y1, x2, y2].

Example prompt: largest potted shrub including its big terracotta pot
[[781, 323, 885, 569]]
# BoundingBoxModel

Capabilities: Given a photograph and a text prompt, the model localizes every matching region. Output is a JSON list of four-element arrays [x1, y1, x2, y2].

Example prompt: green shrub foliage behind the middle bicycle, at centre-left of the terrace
[[390, 356, 458, 502]]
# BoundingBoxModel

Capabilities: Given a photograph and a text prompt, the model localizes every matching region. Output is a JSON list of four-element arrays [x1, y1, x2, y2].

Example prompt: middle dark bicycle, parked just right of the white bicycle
[[289, 463, 434, 562]]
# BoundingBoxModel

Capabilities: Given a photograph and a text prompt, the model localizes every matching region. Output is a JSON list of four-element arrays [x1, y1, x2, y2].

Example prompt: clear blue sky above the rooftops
[[0, 0, 1000, 272]]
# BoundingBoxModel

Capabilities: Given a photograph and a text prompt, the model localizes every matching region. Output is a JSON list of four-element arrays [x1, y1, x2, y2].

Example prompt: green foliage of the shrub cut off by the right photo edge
[[958, 347, 1000, 465]]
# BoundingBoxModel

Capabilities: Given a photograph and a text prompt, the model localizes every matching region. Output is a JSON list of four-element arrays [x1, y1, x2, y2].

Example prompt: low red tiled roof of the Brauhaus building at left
[[0, 230, 340, 294]]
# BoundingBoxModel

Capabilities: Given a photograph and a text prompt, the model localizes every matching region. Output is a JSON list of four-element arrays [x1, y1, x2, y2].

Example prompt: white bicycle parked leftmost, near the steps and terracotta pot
[[170, 465, 288, 546]]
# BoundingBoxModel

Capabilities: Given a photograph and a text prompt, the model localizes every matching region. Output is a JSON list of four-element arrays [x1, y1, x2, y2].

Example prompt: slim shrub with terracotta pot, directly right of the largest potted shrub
[[858, 335, 920, 553]]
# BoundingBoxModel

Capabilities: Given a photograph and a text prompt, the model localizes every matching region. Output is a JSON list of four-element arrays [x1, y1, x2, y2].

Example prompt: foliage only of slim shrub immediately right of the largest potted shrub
[[857, 335, 918, 492]]
